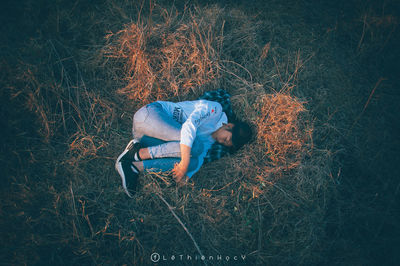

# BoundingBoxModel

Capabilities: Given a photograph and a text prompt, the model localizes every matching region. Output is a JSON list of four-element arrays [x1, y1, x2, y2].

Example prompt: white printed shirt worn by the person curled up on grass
[[157, 100, 228, 178]]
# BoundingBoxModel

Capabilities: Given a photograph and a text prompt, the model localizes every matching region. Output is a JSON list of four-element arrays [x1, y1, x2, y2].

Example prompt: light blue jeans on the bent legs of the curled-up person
[[132, 102, 203, 176]]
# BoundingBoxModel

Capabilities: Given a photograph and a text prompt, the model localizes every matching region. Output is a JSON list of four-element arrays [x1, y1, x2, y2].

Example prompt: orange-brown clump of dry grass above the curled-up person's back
[[103, 5, 219, 104]]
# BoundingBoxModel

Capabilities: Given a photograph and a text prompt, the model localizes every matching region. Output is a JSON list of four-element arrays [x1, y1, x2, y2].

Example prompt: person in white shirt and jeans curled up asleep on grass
[[115, 97, 252, 197]]
